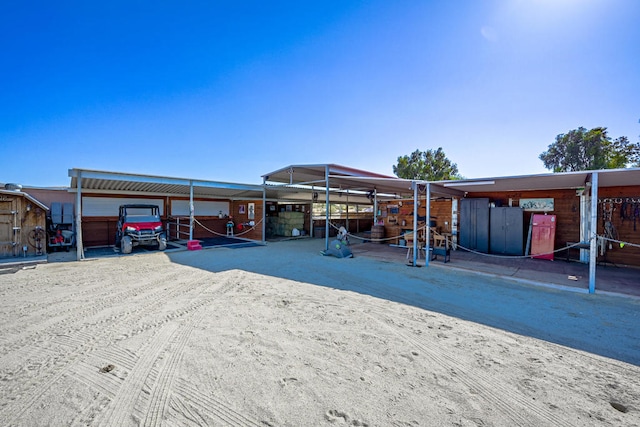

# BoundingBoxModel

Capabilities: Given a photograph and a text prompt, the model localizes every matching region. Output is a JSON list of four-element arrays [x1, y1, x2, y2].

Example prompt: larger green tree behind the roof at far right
[[539, 127, 640, 172]]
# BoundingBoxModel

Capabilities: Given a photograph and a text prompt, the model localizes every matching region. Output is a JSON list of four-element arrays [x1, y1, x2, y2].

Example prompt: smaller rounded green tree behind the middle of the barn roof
[[393, 147, 462, 181]]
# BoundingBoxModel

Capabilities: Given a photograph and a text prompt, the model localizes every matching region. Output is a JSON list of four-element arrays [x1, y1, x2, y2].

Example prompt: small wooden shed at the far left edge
[[0, 184, 49, 257]]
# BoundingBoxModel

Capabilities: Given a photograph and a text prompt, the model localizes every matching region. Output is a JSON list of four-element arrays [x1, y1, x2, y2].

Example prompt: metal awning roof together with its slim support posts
[[69, 164, 640, 293]]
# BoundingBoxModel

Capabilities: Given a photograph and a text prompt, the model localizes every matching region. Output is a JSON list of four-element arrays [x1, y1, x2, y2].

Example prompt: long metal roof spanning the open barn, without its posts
[[69, 164, 640, 203]]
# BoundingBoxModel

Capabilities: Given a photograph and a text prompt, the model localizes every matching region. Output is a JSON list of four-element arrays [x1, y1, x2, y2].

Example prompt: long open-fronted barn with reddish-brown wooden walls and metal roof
[[56, 164, 640, 296]]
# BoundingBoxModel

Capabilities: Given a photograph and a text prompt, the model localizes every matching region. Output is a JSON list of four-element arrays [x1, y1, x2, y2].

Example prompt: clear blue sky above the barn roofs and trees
[[0, 0, 640, 186]]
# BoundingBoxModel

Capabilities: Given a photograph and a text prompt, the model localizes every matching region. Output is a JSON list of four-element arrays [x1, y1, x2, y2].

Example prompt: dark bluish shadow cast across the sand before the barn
[[167, 239, 640, 365]]
